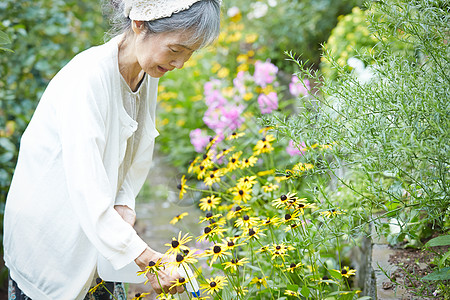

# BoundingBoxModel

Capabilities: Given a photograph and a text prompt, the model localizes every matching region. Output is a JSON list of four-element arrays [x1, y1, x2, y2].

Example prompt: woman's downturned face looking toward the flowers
[[131, 22, 199, 78]]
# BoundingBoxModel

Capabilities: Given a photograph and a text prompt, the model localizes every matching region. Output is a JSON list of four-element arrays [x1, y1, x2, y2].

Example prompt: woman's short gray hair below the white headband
[[104, 0, 220, 48]]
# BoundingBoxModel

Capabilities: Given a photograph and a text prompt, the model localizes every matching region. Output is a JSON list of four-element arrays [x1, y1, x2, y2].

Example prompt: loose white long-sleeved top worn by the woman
[[4, 37, 158, 300]]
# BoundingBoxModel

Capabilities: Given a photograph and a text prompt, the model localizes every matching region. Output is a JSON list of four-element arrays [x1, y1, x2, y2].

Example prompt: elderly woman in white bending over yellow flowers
[[4, 0, 220, 300]]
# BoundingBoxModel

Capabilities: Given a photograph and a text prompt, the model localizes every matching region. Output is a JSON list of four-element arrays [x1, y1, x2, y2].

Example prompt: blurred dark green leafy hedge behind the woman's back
[[0, 0, 106, 288]]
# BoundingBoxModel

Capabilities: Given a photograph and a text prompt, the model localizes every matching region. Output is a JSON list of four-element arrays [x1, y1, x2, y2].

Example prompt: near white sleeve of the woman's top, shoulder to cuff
[[57, 70, 147, 269]]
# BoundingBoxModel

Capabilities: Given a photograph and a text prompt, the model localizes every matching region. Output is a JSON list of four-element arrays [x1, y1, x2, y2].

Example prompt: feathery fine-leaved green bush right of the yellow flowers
[[268, 0, 450, 245]]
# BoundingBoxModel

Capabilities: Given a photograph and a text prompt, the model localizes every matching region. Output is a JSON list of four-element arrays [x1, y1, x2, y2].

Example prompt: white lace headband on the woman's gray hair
[[124, 0, 222, 21]]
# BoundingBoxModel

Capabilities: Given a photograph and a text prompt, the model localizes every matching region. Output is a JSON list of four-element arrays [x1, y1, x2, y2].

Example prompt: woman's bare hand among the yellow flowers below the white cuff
[[135, 248, 184, 294]]
